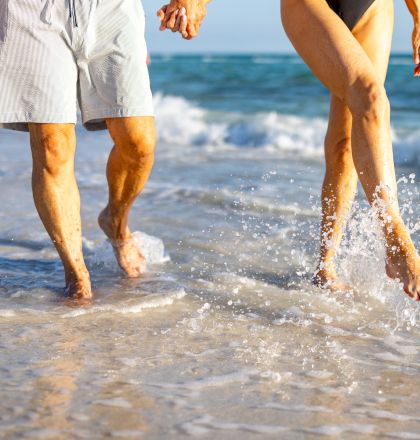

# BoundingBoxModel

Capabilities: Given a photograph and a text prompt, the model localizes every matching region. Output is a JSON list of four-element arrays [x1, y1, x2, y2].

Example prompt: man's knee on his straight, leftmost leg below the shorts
[[31, 128, 75, 176]]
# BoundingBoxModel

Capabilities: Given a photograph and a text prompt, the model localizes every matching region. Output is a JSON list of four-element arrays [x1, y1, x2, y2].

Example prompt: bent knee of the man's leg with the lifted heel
[[113, 121, 156, 162]]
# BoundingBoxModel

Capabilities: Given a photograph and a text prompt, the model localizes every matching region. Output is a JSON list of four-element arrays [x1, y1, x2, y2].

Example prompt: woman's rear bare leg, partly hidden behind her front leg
[[314, 1, 396, 290]]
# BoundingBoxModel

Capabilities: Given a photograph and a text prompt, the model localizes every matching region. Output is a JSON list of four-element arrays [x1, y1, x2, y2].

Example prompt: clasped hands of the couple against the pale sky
[[157, 0, 208, 40]]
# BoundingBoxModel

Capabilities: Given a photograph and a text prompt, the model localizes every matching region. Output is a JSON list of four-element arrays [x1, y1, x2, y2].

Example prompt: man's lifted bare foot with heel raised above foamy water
[[98, 208, 146, 278]]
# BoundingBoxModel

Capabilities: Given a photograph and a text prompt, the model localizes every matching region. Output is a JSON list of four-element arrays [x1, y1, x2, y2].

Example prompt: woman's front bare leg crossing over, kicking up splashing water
[[281, 0, 420, 299]]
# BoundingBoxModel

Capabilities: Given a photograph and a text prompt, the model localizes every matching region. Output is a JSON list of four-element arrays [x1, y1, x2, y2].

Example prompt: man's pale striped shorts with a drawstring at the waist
[[0, 0, 153, 130]]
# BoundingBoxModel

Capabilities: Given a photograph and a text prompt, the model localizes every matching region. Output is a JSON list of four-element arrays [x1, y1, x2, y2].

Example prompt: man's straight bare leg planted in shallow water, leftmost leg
[[29, 124, 92, 299]]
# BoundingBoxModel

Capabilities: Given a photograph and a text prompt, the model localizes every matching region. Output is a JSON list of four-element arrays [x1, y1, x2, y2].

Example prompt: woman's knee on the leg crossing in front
[[348, 78, 389, 123]]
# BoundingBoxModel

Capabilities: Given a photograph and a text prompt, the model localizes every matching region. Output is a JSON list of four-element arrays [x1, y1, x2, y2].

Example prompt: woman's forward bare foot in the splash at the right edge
[[386, 228, 420, 301]]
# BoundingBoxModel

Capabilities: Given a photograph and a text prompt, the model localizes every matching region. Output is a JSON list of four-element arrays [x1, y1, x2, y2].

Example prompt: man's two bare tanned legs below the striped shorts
[[29, 117, 156, 301]]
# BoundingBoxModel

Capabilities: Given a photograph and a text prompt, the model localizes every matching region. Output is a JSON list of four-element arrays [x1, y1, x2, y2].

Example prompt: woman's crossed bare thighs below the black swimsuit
[[281, 0, 392, 100]]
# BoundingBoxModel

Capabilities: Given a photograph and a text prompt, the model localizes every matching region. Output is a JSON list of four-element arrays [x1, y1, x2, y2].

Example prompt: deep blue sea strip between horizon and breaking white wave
[[150, 54, 420, 122]]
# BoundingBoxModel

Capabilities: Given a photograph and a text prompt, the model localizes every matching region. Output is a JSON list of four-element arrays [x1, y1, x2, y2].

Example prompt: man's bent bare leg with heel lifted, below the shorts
[[98, 117, 156, 277]]
